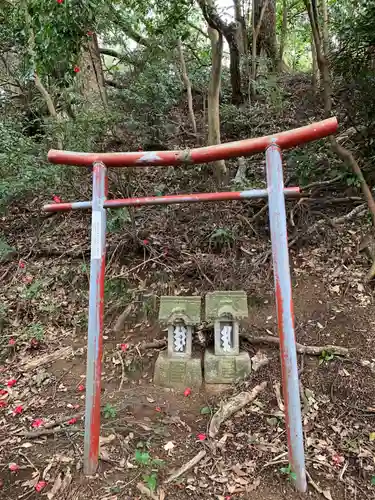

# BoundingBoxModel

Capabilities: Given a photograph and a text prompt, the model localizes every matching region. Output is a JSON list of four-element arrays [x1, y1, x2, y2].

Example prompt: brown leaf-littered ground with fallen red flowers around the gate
[[0, 75, 375, 500]]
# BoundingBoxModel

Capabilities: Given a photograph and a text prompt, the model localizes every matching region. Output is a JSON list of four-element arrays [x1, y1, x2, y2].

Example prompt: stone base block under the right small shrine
[[204, 349, 251, 384]]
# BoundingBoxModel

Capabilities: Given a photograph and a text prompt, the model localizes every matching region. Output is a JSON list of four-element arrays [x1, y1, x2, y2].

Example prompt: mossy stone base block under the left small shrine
[[154, 351, 202, 389]]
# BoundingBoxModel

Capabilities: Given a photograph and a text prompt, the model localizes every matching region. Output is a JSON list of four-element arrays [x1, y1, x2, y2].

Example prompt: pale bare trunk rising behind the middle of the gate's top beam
[[207, 26, 227, 185]]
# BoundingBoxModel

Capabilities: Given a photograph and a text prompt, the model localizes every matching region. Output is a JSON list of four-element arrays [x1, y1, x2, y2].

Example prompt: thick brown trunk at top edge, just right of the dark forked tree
[[253, 0, 278, 71]]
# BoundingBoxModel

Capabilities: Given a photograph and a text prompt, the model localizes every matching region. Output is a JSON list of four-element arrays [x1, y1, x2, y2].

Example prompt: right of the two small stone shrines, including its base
[[204, 291, 251, 384]]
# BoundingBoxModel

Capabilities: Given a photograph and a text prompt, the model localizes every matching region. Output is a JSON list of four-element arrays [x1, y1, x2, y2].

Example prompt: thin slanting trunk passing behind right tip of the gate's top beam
[[305, 0, 375, 227]]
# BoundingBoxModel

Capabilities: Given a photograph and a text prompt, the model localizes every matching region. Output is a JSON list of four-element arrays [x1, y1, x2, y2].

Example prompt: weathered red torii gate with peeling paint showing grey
[[43, 118, 338, 492]]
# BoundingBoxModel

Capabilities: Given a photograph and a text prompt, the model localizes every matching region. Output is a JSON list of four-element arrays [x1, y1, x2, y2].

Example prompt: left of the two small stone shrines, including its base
[[154, 296, 202, 388]]
